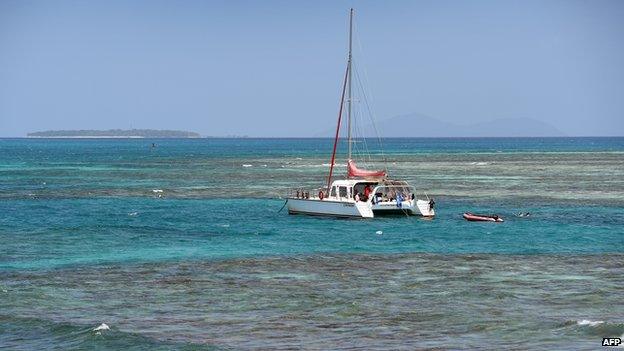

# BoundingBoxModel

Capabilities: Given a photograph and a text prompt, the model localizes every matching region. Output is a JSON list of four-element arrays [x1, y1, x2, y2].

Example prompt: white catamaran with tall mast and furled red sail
[[286, 9, 435, 218]]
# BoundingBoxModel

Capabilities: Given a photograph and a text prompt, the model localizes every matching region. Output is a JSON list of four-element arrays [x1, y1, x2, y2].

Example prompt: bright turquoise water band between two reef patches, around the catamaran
[[0, 198, 624, 269]]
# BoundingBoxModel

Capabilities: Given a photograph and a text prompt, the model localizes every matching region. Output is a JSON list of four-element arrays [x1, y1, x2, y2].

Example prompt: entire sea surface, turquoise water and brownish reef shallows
[[0, 138, 624, 350]]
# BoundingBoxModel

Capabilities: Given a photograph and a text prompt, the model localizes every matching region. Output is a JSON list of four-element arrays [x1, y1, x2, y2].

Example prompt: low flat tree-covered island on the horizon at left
[[27, 129, 200, 138]]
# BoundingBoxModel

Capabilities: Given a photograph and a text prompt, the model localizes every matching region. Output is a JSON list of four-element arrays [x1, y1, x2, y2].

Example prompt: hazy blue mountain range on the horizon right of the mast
[[319, 113, 565, 137]]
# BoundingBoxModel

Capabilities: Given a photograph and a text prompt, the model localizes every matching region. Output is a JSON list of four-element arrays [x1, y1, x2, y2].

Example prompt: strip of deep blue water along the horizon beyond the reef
[[0, 137, 624, 161]]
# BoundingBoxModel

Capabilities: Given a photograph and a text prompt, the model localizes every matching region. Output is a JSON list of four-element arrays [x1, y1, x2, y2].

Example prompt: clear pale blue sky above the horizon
[[0, 0, 624, 136]]
